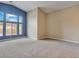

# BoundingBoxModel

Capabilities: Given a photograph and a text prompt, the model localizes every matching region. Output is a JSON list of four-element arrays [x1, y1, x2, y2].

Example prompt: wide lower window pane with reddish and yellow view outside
[[6, 23, 17, 35]]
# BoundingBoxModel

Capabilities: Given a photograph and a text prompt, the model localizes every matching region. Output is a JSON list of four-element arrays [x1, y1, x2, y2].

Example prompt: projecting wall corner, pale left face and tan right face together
[[27, 8, 46, 40]]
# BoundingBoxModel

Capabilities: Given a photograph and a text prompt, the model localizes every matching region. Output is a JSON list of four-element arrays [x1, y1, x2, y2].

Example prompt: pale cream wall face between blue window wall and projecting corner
[[27, 8, 38, 40]]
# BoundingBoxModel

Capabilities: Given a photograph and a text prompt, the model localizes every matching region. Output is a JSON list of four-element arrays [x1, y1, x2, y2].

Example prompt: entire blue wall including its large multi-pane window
[[0, 3, 26, 39]]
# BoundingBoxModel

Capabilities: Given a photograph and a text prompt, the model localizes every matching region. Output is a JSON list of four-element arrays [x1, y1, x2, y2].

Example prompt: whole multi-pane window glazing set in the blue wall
[[0, 12, 23, 36]]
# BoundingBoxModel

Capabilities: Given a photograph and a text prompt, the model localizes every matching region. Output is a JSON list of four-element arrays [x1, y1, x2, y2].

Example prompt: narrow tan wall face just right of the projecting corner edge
[[38, 8, 46, 39]]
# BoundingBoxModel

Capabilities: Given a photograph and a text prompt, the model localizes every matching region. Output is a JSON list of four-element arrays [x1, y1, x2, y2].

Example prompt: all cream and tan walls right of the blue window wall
[[27, 6, 79, 42]]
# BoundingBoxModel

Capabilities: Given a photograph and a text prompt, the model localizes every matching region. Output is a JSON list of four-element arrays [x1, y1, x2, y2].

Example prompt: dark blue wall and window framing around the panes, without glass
[[0, 3, 27, 39]]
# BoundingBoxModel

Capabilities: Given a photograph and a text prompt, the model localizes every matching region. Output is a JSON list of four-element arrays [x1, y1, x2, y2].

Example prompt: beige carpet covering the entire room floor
[[0, 38, 79, 58]]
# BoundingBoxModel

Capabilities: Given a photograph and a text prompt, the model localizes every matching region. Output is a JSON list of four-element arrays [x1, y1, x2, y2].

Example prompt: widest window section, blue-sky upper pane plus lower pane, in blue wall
[[6, 13, 18, 35]]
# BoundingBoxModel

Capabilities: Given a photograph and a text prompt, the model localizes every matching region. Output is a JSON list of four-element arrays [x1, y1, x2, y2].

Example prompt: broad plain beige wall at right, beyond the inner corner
[[47, 6, 79, 42]]
